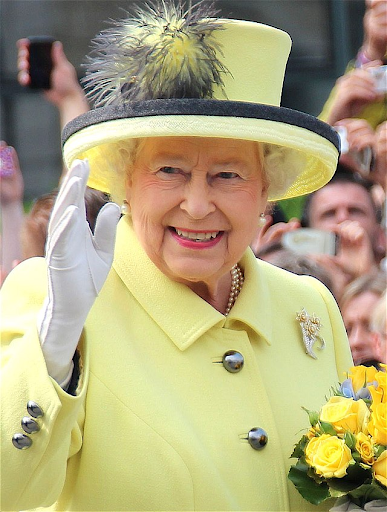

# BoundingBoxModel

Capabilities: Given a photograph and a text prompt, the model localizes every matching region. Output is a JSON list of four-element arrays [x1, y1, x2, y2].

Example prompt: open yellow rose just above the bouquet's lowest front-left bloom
[[320, 396, 369, 434]]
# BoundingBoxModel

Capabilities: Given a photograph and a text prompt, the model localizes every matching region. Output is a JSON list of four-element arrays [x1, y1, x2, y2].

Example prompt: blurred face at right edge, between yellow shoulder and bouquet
[[342, 292, 381, 365]]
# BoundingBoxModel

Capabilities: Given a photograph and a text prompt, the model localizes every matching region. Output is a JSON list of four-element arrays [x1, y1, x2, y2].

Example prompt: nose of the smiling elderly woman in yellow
[[180, 180, 216, 219]]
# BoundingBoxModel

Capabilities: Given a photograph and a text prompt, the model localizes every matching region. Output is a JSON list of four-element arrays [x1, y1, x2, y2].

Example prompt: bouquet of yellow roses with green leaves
[[289, 365, 387, 511]]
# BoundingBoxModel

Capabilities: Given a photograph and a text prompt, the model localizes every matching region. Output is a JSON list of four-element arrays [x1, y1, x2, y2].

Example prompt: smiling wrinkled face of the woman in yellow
[[126, 137, 267, 284]]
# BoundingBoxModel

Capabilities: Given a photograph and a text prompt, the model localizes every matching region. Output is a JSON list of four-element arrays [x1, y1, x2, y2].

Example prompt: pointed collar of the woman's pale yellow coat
[[113, 217, 271, 350]]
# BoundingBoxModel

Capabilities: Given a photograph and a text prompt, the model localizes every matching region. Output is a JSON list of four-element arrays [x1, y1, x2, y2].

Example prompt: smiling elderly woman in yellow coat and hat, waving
[[2, 4, 351, 511]]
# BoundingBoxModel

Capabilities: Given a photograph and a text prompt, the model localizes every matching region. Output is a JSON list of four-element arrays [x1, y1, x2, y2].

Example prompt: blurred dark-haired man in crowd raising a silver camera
[[252, 166, 386, 298]]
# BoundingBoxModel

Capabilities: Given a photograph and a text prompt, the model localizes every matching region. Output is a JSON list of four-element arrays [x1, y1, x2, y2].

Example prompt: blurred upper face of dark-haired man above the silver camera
[[309, 183, 378, 237]]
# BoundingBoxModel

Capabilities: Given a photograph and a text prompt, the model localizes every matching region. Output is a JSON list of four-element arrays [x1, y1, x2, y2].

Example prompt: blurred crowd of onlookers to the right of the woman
[[252, 0, 387, 364]]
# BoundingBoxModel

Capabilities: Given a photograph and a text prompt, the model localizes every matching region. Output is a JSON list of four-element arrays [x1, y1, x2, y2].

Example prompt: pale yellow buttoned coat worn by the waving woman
[[1, 219, 352, 511]]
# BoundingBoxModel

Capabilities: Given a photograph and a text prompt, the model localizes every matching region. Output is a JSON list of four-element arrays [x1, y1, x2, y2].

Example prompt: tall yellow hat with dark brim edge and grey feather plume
[[63, 2, 339, 202]]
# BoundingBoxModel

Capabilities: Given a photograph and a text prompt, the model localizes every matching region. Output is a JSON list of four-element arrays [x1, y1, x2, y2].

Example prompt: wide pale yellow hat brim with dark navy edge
[[62, 99, 339, 201]]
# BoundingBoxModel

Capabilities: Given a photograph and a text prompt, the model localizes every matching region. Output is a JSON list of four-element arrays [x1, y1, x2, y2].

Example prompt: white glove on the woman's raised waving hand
[[38, 160, 120, 389]]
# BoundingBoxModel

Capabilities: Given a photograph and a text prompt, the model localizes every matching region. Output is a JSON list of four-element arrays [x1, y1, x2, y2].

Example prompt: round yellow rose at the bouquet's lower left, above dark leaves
[[305, 434, 352, 478]]
